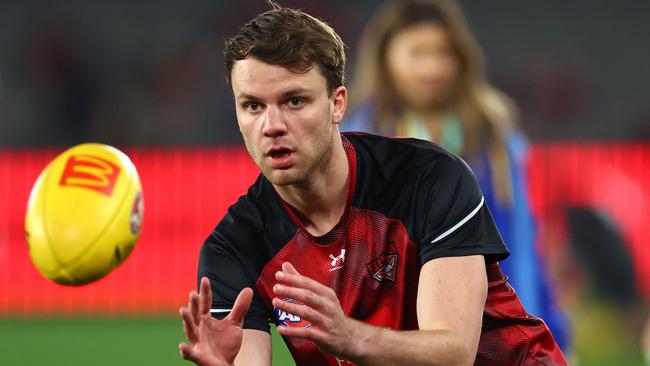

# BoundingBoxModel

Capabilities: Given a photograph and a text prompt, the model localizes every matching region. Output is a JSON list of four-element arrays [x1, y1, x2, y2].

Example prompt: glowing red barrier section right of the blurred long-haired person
[[529, 142, 650, 299]]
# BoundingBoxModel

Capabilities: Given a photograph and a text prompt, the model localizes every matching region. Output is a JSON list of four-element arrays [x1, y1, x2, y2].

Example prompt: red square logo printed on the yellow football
[[59, 154, 120, 197]]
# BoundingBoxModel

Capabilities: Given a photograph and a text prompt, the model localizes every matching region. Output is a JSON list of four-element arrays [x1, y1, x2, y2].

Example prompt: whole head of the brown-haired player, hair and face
[[224, 6, 347, 186]]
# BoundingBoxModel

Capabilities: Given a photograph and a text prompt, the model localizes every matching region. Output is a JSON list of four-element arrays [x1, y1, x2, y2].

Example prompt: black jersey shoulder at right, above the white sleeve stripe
[[344, 133, 472, 224]]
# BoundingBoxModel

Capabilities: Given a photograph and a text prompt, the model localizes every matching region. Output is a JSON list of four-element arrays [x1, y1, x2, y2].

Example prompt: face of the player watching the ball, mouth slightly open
[[231, 57, 347, 186]]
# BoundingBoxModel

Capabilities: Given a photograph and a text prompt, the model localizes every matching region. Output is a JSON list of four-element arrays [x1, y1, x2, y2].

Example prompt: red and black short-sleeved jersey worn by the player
[[198, 133, 565, 366]]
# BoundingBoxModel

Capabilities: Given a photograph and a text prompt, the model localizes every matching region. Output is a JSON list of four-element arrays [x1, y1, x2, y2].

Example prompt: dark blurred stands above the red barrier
[[0, 0, 650, 147]]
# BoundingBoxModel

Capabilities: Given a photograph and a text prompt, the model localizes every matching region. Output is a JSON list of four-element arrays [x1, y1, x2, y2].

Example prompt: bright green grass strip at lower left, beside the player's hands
[[0, 318, 295, 366]]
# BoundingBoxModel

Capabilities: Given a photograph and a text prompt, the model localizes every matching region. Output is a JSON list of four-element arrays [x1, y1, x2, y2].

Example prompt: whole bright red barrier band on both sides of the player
[[0, 143, 650, 317]]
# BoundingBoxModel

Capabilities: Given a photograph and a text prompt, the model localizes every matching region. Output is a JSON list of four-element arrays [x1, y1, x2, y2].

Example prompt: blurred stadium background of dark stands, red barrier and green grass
[[0, 0, 650, 365]]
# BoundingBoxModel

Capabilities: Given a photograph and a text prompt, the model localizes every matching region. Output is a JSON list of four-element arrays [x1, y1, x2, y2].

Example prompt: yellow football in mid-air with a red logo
[[25, 143, 144, 285]]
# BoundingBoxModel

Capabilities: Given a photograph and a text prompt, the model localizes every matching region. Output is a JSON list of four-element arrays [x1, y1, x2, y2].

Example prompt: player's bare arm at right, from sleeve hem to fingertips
[[273, 255, 487, 366]]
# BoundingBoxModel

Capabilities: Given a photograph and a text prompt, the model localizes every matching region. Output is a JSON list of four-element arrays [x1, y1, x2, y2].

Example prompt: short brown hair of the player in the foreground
[[223, 1, 345, 92]]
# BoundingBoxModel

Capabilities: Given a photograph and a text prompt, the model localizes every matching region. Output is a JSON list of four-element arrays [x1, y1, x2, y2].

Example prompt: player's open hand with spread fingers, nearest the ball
[[178, 277, 253, 366]]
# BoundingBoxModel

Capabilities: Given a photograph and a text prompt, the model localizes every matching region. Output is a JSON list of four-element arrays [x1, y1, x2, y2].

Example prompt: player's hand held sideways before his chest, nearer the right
[[273, 262, 358, 358]]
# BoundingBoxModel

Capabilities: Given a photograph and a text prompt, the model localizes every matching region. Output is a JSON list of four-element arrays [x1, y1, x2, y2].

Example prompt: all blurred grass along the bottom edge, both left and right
[[0, 312, 644, 366]]
